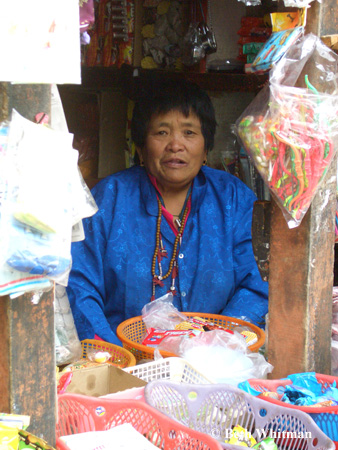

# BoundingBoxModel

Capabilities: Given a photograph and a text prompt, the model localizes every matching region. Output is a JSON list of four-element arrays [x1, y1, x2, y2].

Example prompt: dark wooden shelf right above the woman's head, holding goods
[[70, 64, 268, 98]]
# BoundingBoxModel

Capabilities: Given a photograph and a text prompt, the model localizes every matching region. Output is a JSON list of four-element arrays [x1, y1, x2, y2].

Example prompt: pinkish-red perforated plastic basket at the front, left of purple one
[[56, 394, 222, 450]]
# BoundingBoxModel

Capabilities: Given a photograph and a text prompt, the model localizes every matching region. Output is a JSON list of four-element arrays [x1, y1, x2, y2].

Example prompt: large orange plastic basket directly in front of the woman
[[116, 312, 265, 361]]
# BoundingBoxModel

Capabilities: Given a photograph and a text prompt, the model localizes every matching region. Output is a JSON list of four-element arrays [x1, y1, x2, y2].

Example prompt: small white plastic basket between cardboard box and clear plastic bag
[[123, 356, 212, 384]]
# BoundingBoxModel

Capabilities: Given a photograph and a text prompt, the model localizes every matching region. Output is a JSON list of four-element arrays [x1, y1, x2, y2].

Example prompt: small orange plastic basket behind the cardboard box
[[81, 339, 136, 369]]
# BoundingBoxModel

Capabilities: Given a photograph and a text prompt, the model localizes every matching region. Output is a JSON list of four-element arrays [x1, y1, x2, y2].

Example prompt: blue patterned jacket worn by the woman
[[67, 166, 268, 344]]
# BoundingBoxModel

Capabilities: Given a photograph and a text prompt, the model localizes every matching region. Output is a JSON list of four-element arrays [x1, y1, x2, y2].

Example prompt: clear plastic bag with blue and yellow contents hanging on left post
[[0, 110, 95, 295]]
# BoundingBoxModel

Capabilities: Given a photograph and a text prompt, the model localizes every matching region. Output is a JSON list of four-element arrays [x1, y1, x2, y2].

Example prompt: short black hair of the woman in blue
[[131, 79, 217, 151]]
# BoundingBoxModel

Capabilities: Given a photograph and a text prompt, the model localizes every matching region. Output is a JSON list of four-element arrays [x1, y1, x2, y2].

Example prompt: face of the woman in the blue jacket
[[139, 110, 207, 193]]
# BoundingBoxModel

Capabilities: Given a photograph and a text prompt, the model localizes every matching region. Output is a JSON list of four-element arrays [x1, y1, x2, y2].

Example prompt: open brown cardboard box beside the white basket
[[66, 364, 147, 397]]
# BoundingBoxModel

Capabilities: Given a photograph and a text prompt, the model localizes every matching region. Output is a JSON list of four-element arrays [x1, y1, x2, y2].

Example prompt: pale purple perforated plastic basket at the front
[[144, 380, 335, 450]]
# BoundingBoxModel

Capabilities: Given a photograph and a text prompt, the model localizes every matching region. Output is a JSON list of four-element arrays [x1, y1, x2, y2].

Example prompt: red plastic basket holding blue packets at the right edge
[[243, 373, 338, 450]]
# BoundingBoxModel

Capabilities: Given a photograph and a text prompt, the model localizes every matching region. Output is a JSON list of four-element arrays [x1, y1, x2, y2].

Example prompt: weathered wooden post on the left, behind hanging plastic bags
[[0, 83, 56, 445]]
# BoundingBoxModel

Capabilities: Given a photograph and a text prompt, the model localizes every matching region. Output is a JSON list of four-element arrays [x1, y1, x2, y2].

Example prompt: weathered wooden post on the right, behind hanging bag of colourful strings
[[268, 0, 337, 378]]
